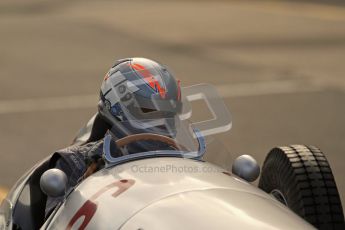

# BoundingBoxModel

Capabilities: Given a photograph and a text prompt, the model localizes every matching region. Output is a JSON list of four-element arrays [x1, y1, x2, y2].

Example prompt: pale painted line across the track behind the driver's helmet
[[0, 81, 322, 115]]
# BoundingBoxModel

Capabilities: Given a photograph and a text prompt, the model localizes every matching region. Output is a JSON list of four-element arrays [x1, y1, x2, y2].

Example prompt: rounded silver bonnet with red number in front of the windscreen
[[42, 157, 313, 229]]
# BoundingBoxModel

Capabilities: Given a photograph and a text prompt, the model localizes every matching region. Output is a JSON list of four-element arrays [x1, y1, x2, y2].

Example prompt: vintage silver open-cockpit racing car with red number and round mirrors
[[0, 84, 345, 230]]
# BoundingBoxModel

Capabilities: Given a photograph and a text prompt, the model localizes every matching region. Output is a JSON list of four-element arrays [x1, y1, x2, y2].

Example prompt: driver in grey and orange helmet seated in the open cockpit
[[45, 58, 182, 217]]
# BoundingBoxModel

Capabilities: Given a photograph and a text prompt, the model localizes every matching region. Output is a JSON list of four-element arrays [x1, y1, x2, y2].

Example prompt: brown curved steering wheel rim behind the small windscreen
[[116, 133, 187, 151]]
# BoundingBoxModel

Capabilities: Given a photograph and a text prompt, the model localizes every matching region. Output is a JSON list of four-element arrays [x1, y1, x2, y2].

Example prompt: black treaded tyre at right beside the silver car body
[[259, 145, 345, 230]]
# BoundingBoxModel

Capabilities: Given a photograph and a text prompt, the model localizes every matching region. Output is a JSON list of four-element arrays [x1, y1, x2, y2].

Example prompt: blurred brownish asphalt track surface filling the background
[[0, 0, 345, 208]]
